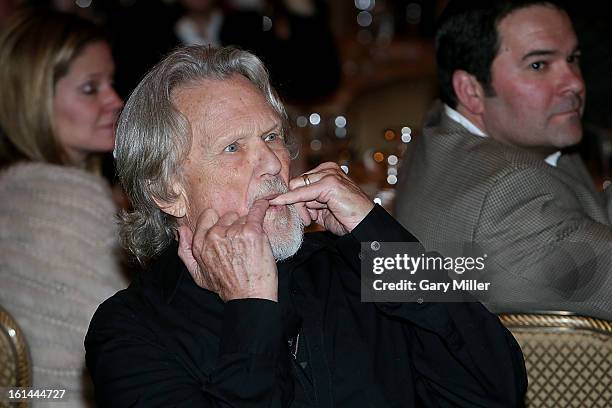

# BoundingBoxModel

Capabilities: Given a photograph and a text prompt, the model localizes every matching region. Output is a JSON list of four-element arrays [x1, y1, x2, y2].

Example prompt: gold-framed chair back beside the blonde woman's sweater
[[0, 307, 31, 408]]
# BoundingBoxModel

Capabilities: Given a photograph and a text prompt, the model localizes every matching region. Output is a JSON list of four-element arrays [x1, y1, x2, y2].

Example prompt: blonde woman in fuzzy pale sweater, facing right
[[0, 9, 124, 407]]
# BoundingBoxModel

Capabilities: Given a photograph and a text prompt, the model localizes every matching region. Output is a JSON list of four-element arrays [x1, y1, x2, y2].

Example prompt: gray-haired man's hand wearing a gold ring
[[270, 162, 374, 235]]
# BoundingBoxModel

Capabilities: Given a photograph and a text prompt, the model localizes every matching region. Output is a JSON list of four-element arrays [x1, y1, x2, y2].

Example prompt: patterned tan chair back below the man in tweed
[[499, 312, 612, 408]]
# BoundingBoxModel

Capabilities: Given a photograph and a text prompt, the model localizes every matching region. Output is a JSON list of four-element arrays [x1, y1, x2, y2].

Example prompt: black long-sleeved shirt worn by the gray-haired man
[[85, 206, 527, 408]]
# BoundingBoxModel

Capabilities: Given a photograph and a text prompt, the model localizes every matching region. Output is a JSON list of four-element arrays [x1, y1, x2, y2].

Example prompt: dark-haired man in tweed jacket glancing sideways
[[396, 1, 612, 319]]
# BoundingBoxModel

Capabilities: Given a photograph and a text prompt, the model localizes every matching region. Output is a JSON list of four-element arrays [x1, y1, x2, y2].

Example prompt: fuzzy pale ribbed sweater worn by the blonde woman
[[0, 163, 125, 407]]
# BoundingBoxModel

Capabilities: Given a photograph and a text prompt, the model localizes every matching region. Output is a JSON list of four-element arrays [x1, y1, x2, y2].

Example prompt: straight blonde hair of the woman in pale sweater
[[0, 9, 106, 167]]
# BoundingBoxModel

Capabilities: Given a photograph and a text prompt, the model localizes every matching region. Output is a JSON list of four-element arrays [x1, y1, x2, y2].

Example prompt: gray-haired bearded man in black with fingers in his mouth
[[85, 47, 526, 407]]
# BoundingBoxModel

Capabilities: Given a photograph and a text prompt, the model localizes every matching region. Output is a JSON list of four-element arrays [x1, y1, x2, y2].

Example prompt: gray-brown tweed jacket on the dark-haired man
[[395, 104, 612, 320]]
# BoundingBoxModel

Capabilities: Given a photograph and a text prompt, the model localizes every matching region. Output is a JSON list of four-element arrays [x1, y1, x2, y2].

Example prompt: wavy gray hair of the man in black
[[114, 46, 295, 266]]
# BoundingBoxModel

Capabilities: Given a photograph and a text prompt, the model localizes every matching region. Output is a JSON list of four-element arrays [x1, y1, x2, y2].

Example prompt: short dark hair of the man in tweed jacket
[[435, 0, 564, 108]]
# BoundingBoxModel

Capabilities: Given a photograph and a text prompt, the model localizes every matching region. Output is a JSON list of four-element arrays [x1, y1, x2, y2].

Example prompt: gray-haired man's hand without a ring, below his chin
[[178, 200, 278, 302]]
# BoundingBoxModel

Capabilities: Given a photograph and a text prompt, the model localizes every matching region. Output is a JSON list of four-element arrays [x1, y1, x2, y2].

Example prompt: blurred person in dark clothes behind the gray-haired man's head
[[108, 0, 340, 102]]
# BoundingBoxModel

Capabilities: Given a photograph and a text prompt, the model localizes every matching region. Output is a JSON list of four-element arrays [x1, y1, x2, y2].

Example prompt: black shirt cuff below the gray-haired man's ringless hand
[[219, 299, 283, 358]]
